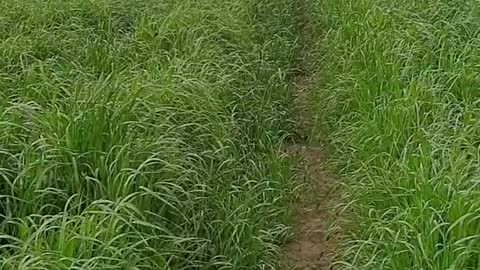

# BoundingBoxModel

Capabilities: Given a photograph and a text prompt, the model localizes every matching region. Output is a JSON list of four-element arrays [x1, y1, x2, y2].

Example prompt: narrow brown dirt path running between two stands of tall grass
[[284, 0, 343, 270]]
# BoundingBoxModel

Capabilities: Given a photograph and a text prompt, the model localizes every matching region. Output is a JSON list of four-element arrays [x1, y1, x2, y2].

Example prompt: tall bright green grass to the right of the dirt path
[[309, 0, 480, 270]]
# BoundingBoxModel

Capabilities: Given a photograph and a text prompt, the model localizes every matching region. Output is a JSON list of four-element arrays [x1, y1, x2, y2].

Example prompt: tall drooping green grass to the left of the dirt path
[[0, 0, 296, 270]]
